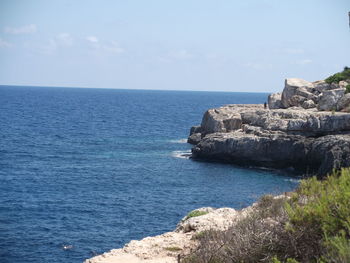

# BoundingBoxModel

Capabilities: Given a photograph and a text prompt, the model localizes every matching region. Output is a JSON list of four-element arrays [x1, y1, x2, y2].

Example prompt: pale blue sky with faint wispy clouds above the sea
[[0, 0, 350, 92]]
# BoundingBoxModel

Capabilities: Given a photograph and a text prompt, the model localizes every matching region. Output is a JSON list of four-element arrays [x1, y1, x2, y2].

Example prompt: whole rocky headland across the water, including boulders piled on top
[[188, 79, 350, 176]]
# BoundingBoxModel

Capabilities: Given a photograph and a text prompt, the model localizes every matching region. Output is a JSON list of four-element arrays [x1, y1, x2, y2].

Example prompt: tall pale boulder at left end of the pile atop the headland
[[281, 78, 314, 108]]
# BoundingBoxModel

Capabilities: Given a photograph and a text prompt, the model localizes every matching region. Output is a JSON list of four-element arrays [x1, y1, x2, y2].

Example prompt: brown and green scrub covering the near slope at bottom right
[[182, 169, 350, 263]]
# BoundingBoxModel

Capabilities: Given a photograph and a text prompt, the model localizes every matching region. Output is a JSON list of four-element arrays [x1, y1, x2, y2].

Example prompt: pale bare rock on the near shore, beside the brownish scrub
[[85, 200, 274, 263]]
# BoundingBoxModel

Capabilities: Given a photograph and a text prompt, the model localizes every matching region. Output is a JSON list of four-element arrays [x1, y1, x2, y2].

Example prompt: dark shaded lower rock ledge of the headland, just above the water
[[192, 131, 350, 176]]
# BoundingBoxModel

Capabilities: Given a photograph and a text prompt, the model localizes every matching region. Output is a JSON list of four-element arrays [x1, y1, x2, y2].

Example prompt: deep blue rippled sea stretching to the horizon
[[0, 86, 297, 263]]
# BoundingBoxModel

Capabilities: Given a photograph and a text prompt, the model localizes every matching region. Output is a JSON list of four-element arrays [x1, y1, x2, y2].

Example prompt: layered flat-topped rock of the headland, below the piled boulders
[[192, 105, 350, 175]]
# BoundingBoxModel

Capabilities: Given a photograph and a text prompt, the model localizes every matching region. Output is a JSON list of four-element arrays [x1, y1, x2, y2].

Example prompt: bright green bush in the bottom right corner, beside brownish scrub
[[286, 169, 350, 262]]
